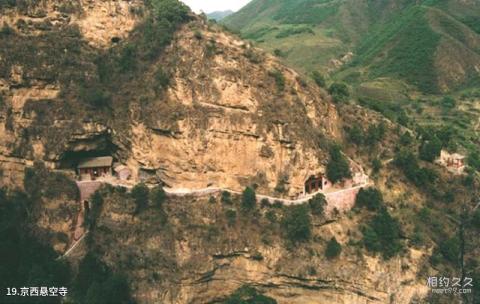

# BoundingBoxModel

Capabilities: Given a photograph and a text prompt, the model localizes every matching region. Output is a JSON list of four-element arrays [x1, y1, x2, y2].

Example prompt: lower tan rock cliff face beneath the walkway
[[88, 190, 428, 304]]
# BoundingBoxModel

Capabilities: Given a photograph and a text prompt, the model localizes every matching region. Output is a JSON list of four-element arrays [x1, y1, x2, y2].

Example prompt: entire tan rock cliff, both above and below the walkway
[[0, 1, 434, 304]]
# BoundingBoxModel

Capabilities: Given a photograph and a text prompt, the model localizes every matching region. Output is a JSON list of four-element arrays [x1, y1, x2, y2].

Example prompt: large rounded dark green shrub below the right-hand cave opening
[[282, 205, 312, 243]]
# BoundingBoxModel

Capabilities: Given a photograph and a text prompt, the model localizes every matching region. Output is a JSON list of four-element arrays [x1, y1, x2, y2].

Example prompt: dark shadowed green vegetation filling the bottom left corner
[[0, 189, 71, 303]]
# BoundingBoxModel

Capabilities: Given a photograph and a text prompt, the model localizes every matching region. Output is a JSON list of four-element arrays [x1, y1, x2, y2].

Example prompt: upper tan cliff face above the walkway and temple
[[0, 1, 339, 194]]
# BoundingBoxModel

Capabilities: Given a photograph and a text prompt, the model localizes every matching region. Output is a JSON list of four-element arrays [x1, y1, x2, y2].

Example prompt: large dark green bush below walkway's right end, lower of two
[[362, 208, 403, 259]]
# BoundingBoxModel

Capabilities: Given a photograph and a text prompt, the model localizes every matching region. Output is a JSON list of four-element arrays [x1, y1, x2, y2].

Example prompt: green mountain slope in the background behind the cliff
[[224, 0, 480, 93]]
